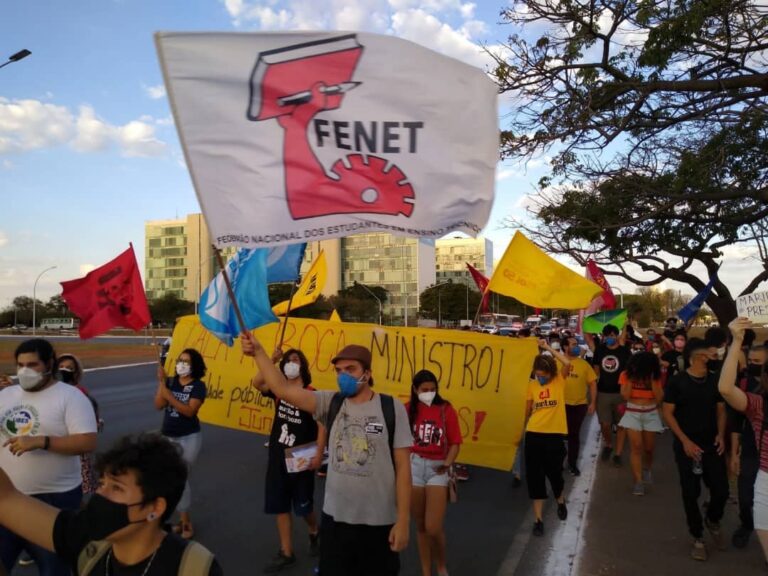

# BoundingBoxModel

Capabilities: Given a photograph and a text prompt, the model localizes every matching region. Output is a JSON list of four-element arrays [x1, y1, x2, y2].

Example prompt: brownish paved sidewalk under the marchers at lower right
[[573, 431, 768, 576]]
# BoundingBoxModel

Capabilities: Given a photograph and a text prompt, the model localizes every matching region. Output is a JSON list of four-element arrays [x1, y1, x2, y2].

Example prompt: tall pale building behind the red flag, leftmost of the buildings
[[144, 214, 219, 302]]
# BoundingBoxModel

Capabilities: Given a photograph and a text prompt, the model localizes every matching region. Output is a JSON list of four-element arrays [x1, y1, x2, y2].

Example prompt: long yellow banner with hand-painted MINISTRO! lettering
[[168, 316, 537, 470]]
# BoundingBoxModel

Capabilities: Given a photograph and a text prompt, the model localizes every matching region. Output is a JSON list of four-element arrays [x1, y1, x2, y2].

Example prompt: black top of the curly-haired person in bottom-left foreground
[[53, 510, 224, 576]]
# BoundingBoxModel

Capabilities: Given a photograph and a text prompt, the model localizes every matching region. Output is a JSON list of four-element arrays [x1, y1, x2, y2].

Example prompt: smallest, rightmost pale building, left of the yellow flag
[[435, 237, 493, 288]]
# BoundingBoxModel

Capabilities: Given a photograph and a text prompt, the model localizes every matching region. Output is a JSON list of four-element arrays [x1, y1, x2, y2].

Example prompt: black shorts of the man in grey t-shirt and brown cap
[[320, 514, 400, 576]]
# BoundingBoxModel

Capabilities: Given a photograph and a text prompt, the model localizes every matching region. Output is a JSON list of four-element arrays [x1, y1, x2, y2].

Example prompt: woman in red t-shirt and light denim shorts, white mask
[[405, 370, 461, 576]]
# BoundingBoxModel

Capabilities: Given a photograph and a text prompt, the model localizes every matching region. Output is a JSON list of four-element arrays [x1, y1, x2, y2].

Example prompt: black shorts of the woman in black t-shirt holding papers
[[264, 459, 315, 516]]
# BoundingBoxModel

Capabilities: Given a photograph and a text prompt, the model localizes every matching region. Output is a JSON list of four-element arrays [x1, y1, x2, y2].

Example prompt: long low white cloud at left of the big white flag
[[0, 98, 166, 157]]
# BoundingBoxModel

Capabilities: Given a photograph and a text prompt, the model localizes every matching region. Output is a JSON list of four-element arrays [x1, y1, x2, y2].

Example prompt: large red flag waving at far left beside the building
[[61, 245, 152, 339]]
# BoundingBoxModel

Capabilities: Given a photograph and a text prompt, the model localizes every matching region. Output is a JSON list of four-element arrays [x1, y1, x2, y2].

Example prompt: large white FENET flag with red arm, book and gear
[[155, 32, 499, 248]]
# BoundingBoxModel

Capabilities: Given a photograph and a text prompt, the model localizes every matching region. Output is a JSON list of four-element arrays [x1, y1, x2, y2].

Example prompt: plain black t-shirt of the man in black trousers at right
[[664, 372, 724, 451]]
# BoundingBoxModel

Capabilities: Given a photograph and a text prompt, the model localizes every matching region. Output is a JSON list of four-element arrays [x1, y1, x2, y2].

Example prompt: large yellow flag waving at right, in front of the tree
[[487, 232, 603, 310]]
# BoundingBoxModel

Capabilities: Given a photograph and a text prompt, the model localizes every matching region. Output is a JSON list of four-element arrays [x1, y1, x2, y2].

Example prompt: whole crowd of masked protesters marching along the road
[[0, 310, 768, 576]]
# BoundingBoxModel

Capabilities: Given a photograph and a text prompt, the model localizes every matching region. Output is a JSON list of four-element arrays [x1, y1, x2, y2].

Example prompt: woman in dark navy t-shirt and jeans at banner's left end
[[155, 348, 207, 539]]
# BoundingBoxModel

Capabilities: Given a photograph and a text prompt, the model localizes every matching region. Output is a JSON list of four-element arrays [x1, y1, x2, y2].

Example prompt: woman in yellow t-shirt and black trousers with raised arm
[[525, 340, 571, 536]]
